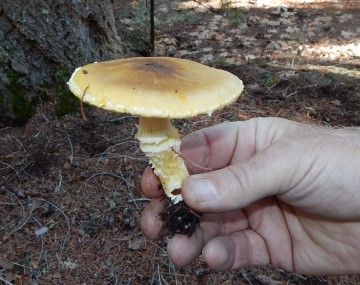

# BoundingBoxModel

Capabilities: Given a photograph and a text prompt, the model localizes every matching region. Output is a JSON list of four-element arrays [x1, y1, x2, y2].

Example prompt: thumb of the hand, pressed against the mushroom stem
[[182, 144, 306, 212]]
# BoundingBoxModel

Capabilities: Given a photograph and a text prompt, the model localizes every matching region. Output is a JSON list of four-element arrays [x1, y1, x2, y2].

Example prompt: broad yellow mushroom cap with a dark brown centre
[[68, 57, 243, 118]]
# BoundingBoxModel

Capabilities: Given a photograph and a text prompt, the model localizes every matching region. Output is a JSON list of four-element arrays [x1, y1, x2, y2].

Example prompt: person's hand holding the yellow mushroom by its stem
[[141, 118, 360, 274]]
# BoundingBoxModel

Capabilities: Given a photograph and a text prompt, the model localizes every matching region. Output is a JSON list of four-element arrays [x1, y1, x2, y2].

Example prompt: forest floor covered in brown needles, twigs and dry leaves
[[0, 0, 360, 285]]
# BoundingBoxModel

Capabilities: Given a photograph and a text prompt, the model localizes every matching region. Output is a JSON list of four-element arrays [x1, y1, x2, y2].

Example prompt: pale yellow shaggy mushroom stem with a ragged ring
[[136, 117, 189, 203]]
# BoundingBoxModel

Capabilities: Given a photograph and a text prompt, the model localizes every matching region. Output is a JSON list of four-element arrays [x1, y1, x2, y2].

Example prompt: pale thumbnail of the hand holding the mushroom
[[189, 177, 218, 202]]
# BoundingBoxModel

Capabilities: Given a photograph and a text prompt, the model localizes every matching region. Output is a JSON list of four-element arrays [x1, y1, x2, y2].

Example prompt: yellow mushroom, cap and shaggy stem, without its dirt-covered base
[[68, 57, 243, 215]]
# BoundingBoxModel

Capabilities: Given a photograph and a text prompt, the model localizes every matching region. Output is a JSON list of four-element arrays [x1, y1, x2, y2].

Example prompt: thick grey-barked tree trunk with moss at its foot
[[0, 0, 148, 127]]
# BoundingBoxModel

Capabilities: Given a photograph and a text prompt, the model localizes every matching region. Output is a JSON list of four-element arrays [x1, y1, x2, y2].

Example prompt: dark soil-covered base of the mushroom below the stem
[[159, 195, 201, 237]]
